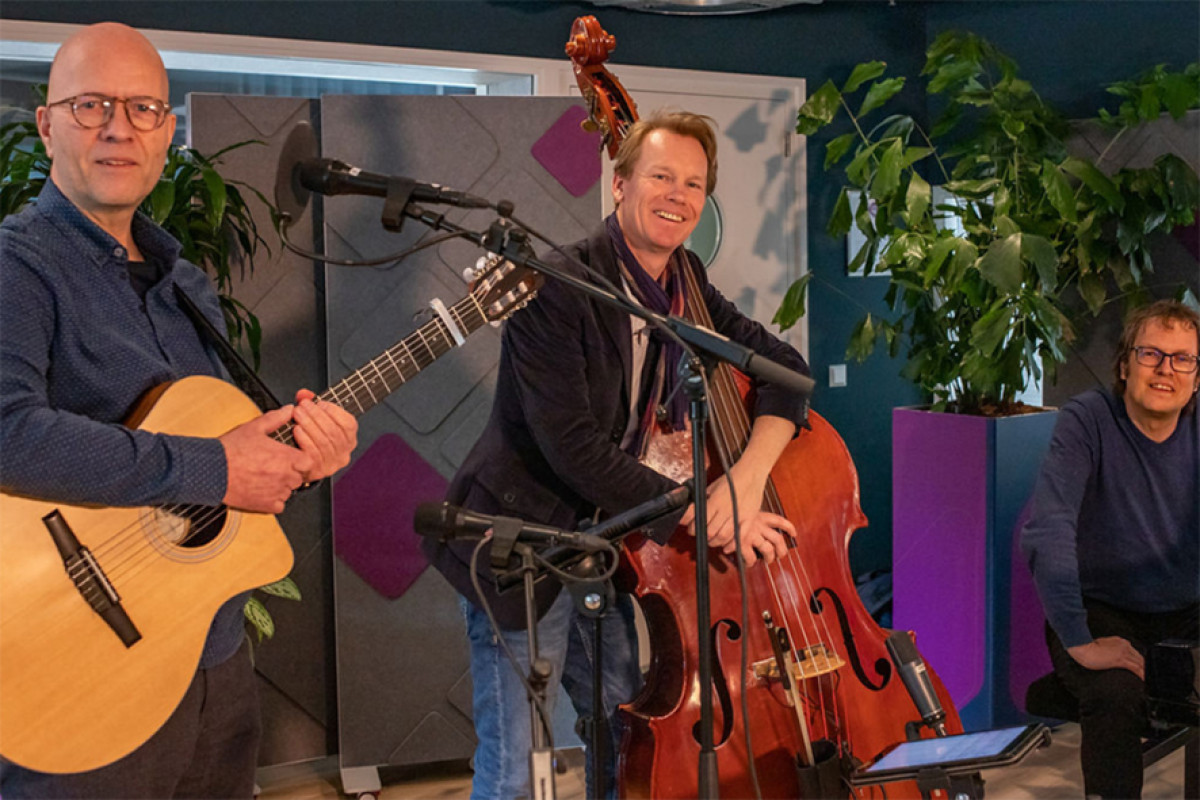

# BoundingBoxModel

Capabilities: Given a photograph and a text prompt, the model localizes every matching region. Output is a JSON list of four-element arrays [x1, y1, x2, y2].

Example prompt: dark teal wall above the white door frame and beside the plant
[[0, 0, 1200, 572]]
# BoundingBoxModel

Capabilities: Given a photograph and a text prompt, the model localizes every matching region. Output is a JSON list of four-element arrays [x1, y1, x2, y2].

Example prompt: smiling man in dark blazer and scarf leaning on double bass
[[426, 112, 808, 800]]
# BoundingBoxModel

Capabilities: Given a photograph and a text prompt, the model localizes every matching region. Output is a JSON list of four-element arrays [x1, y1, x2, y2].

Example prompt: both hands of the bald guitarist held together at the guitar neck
[[220, 389, 359, 513]]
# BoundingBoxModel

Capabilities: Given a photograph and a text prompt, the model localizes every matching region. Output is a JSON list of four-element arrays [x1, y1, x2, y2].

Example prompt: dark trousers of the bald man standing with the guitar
[[0, 643, 263, 800]]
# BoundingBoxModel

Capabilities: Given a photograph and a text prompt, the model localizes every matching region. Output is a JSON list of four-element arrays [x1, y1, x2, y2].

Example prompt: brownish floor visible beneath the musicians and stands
[[259, 723, 1183, 800]]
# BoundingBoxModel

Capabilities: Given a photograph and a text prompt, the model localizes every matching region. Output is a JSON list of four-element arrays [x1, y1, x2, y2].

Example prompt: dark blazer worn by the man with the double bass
[[422, 225, 809, 628]]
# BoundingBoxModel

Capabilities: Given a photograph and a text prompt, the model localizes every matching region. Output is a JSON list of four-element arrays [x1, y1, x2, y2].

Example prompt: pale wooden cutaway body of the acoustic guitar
[[0, 377, 292, 772]]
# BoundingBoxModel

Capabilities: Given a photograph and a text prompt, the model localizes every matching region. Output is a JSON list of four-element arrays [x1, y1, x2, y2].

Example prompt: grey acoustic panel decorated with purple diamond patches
[[320, 96, 601, 789]]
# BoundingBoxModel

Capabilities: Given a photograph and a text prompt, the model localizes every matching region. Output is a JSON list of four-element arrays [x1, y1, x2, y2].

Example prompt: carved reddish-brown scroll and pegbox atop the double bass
[[565, 16, 637, 158]]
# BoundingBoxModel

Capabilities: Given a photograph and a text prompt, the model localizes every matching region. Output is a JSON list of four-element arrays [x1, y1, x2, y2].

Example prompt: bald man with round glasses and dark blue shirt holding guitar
[[0, 23, 358, 800]]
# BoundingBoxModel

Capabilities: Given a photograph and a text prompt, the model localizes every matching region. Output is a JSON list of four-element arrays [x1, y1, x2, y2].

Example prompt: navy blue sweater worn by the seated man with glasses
[[1021, 390, 1200, 648]]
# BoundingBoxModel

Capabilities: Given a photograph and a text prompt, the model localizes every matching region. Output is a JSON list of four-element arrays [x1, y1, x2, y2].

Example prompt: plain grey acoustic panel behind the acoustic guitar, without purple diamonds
[[187, 94, 336, 765]]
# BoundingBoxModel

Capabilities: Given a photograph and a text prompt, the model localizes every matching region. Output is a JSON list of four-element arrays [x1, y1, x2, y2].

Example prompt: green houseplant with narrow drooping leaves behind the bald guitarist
[[0, 95, 300, 640]]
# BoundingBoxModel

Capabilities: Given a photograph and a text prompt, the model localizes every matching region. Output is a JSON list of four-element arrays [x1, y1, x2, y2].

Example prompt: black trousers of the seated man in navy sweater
[[1046, 597, 1200, 800]]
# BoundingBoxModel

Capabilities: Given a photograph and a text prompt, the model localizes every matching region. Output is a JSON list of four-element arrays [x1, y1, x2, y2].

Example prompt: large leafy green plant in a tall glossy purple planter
[[775, 32, 1200, 727]]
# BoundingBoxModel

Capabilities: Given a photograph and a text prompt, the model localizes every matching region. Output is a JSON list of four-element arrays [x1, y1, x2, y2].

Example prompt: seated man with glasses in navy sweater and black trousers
[[1021, 300, 1200, 798]]
